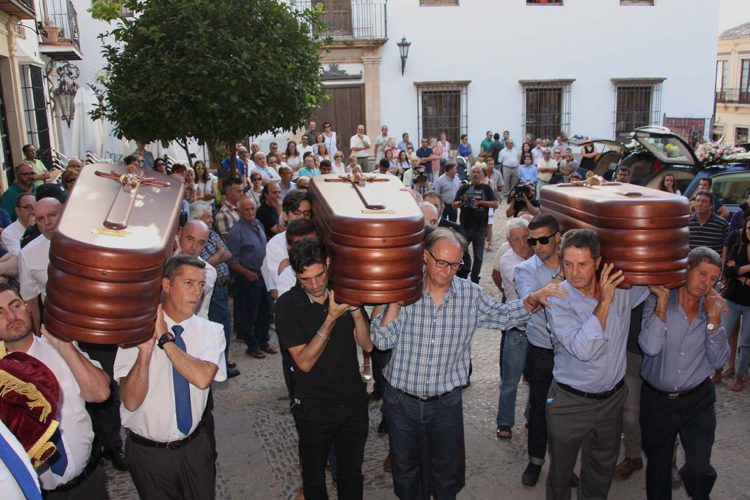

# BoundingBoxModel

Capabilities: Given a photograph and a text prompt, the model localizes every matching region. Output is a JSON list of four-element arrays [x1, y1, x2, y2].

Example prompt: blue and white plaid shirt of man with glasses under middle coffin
[[370, 278, 529, 397]]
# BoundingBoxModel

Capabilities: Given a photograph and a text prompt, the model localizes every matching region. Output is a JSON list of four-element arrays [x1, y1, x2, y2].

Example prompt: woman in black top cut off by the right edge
[[724, 217, 750, 391]]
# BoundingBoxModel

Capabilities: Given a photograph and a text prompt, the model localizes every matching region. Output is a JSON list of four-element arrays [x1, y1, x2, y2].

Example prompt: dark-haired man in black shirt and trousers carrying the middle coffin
[[276, 239, 372, 499]]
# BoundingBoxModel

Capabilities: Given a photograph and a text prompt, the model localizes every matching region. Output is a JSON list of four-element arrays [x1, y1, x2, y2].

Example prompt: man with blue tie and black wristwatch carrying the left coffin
[[114, 255, 226, 500]]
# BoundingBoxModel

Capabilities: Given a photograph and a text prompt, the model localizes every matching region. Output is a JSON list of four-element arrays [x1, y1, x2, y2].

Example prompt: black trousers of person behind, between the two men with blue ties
[[78, 342, 122, 451]]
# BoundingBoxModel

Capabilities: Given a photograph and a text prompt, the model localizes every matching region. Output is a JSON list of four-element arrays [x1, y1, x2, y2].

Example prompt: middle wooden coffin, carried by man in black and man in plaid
[[310, 174, 424, 305]]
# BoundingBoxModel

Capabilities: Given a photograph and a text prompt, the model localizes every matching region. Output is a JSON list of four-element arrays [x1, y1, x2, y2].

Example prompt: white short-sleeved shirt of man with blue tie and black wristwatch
[[114, 314, 227, 443]]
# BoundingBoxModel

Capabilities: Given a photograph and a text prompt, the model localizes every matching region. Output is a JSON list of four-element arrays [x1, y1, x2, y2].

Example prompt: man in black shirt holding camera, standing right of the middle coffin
[[453, 166, 498, 283]]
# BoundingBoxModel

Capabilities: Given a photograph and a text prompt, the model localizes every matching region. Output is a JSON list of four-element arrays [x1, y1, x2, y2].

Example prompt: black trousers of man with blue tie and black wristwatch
[[125, 425, 216, 500]]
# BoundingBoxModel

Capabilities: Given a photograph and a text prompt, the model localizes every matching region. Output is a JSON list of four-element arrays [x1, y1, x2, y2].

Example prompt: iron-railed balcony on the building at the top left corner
[[39, 0, 83, 61]]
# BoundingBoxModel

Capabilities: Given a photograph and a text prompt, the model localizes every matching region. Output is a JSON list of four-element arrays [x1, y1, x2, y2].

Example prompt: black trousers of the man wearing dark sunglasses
[[523, 344, 555, 465]]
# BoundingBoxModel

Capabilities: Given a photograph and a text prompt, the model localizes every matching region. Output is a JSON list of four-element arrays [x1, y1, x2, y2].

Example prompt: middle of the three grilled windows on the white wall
[[519, 80, 574, 139]]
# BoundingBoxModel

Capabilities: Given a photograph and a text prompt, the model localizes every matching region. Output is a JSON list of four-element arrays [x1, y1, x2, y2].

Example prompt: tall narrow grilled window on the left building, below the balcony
[[21, 65, 52, 168]]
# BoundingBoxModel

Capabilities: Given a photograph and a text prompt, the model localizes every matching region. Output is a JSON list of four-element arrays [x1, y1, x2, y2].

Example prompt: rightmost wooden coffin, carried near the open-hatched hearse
[[540, 182, 690, 287]]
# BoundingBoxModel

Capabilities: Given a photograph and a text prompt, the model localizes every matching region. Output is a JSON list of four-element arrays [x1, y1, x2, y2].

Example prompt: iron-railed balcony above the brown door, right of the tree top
[[291, 0, 388, 46]]
